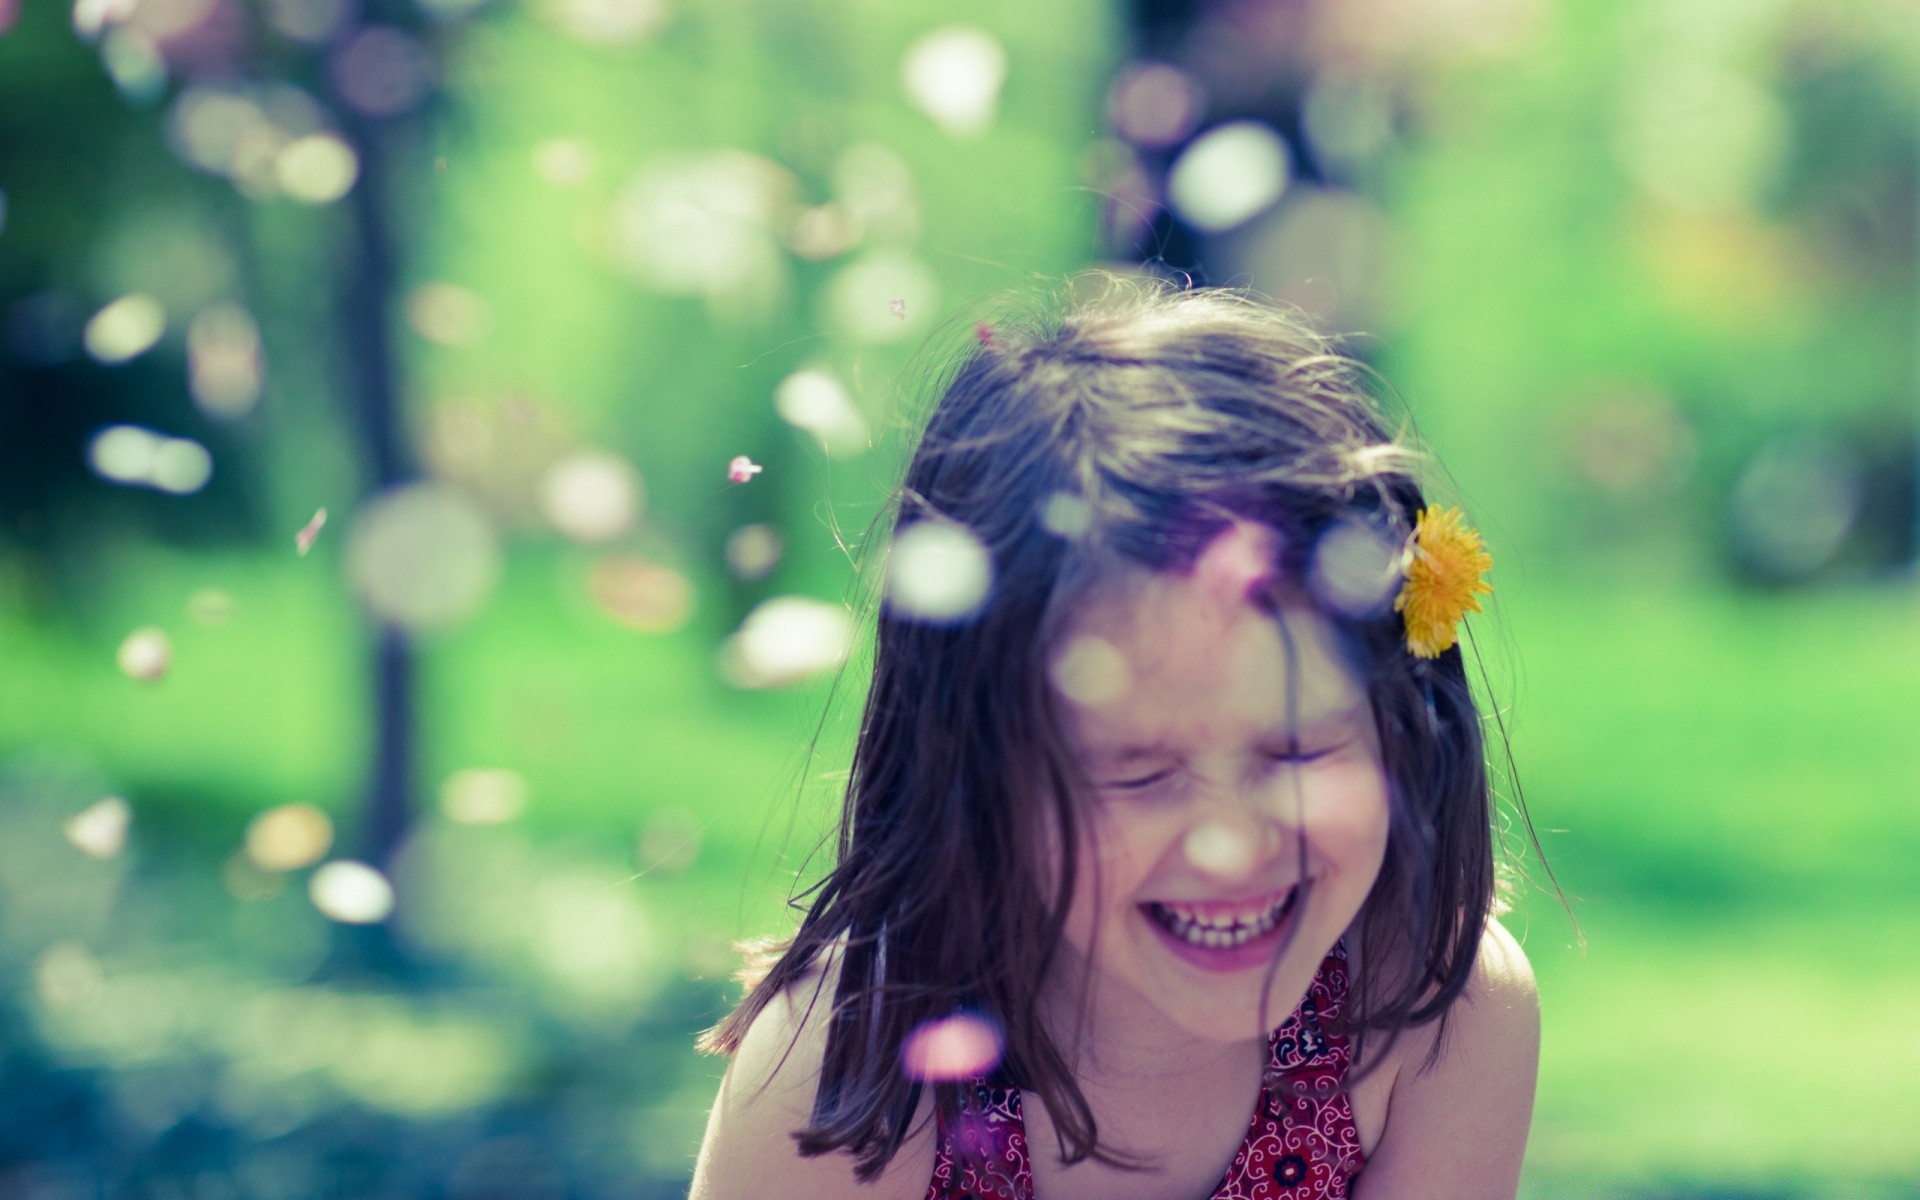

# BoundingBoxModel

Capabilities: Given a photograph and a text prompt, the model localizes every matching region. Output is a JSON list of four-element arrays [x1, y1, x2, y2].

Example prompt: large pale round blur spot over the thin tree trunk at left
[[348, 484, 499, 632]]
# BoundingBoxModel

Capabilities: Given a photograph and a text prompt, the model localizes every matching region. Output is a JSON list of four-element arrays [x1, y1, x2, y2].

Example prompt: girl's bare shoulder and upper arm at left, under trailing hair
[[691, 966, 933, 1200]]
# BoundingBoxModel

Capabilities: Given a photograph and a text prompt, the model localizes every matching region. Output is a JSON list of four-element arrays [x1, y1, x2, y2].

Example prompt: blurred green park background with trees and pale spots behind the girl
[[0, 0, 1920, 1198]]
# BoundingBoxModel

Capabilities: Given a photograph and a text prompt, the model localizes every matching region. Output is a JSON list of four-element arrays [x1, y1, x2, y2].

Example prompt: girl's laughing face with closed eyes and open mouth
[[1052, 561, 1388, 1041]]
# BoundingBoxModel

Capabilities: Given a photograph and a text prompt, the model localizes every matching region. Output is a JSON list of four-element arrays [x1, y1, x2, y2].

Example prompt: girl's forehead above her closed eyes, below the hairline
[[1054, 568, 1365, 749]]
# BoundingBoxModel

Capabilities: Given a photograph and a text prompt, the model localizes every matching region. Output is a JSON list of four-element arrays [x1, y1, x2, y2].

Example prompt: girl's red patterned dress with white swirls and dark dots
[[927, 945, 1363, 1200]]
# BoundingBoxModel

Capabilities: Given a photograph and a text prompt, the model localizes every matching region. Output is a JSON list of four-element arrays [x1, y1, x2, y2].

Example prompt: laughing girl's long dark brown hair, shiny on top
[[703, 276, 1520, 1179]]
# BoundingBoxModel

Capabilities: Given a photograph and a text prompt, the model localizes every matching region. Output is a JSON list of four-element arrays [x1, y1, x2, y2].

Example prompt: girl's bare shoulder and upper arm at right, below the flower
[[1354, 920, 1540, 1200]]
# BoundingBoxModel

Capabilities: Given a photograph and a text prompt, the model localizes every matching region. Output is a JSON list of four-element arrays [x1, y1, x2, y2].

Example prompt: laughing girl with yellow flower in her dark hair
[[693, 280, 1540, 1200]]
